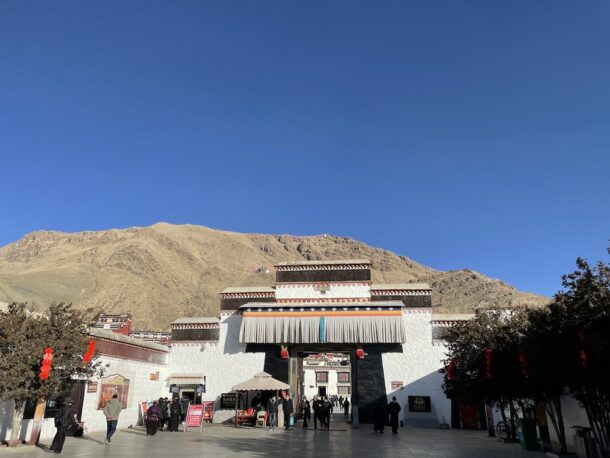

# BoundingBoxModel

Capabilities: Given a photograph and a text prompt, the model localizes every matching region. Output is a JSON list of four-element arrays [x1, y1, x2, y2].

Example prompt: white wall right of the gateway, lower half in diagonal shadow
[[382, 309, 451, 427]]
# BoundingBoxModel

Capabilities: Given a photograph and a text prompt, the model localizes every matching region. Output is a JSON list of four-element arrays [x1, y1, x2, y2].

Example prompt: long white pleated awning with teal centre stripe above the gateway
[[239, 310, 406, 344]]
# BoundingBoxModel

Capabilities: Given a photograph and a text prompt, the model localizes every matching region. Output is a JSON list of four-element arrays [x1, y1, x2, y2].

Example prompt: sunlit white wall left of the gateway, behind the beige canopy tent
[[166, 314, 265, 423]]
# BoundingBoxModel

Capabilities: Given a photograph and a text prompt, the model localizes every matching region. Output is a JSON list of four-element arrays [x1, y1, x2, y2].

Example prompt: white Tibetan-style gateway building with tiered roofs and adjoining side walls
[[0, 260, 579, 450]]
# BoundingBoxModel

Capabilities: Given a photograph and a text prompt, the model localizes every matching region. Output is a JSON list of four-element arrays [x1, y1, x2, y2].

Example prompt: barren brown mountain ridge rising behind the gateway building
[[0, 223, 547, 329]]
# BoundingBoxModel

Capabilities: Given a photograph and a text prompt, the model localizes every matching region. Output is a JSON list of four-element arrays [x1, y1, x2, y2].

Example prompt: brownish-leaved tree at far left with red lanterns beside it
[[0, 303, 99, 445]]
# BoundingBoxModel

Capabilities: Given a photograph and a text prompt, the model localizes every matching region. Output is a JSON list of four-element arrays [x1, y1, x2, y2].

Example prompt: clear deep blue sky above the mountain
[[0, 0, 610, 295]]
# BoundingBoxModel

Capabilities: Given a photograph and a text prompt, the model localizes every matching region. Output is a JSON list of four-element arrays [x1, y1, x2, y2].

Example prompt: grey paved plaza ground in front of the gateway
[[0, 418, 545, 458]]
